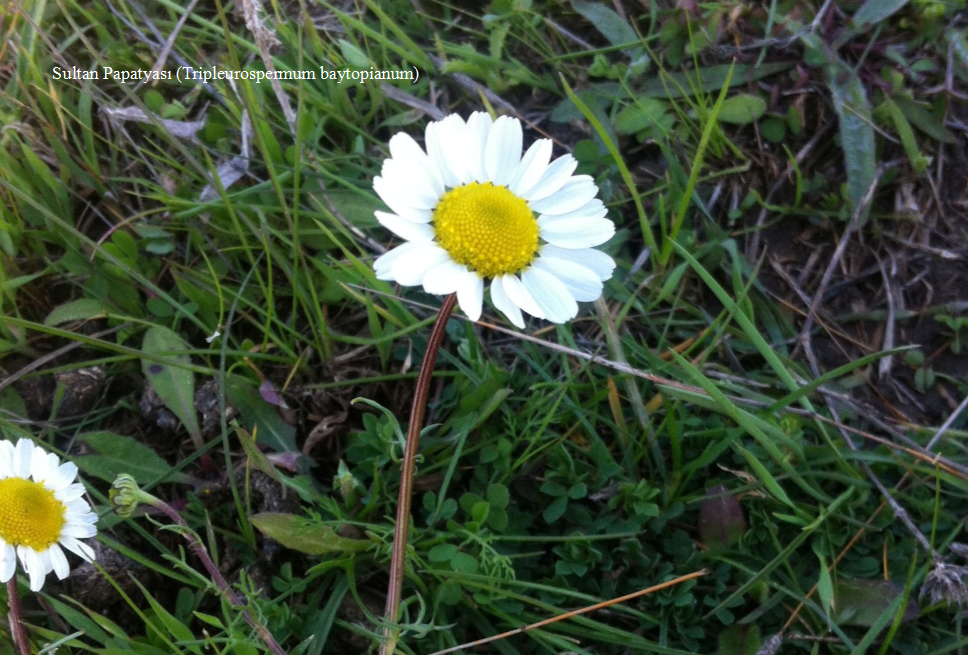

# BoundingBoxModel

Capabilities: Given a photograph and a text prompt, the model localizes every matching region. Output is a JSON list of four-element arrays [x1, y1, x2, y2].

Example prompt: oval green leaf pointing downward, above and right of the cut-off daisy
[[141, 325, 202, 448]]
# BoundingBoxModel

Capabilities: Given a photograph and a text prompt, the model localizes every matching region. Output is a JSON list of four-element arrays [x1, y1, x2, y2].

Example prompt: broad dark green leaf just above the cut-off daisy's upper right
[[73, 432, 192, 484]]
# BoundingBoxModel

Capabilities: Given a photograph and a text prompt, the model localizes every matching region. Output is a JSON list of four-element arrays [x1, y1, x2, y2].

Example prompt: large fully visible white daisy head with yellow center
[[373, 112, 615, 328]]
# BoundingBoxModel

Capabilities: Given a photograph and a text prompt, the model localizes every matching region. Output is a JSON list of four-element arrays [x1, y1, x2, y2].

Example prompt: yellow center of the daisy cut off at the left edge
[[0, 478, 67, 552]]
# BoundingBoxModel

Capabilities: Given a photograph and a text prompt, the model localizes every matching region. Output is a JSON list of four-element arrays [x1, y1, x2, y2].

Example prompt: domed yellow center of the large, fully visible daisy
[[433, 182, 538, 278]]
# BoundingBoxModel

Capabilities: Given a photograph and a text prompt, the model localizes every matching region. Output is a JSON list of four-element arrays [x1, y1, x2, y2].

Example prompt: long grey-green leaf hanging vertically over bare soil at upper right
[[826, 59, 875, 225]]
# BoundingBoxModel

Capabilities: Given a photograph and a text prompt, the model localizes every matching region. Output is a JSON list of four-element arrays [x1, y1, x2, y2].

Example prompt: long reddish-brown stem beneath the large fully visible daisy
[[380, 293, 457, 655]]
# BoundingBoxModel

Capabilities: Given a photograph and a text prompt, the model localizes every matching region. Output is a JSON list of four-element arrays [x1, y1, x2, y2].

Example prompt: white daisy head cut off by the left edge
[[0, 439, 97, 591]]
